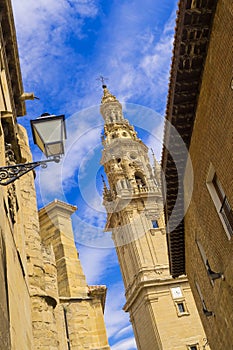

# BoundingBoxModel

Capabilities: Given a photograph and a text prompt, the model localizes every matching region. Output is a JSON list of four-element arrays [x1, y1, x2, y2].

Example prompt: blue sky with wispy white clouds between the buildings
[[12, 0, 177, 350]]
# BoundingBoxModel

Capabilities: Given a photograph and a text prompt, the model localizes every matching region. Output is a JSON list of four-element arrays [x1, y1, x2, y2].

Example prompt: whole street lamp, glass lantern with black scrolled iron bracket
[[0, 113, 66, 186]]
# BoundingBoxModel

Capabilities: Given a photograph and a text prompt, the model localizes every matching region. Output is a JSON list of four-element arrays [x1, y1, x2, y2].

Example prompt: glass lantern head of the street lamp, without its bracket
[[31, 113, 66, 157]]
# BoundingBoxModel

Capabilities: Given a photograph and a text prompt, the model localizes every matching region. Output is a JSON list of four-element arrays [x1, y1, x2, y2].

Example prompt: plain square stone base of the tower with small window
[[124, 277, 206, 350]]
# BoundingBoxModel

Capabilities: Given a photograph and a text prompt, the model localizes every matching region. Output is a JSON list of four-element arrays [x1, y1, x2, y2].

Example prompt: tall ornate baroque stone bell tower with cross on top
[[100, 85, 207, 350]]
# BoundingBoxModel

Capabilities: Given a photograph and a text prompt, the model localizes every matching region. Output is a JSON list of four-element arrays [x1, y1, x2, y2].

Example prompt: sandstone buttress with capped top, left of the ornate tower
[[39, 200, 109, 350]]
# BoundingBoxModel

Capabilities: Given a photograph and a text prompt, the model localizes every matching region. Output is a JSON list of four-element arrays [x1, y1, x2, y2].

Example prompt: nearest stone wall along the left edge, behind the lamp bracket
[[0, 0, 33, 350]]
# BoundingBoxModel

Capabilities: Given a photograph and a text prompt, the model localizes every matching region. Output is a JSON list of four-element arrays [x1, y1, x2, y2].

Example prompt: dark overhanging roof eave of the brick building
[[162, 0, 217, 277]]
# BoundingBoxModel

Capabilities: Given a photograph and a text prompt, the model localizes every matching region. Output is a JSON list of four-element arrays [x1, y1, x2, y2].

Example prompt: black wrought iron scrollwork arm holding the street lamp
[[0, 157, 60, 186]]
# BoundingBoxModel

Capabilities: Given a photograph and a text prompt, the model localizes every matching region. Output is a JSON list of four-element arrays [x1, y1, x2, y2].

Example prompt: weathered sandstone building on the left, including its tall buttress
[[0, 0, 109, 350]]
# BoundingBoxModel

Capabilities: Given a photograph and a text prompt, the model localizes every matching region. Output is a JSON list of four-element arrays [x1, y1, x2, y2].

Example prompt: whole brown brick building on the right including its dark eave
[[162, 0, 233, 350]]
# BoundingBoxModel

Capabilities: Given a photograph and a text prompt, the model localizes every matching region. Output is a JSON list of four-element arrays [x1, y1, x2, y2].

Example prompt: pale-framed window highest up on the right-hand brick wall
[[206, 164, 233, 238]]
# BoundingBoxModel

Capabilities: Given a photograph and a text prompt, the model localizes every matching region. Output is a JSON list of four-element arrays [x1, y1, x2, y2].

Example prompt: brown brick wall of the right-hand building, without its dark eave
[[185, 0, 233, 350]]
